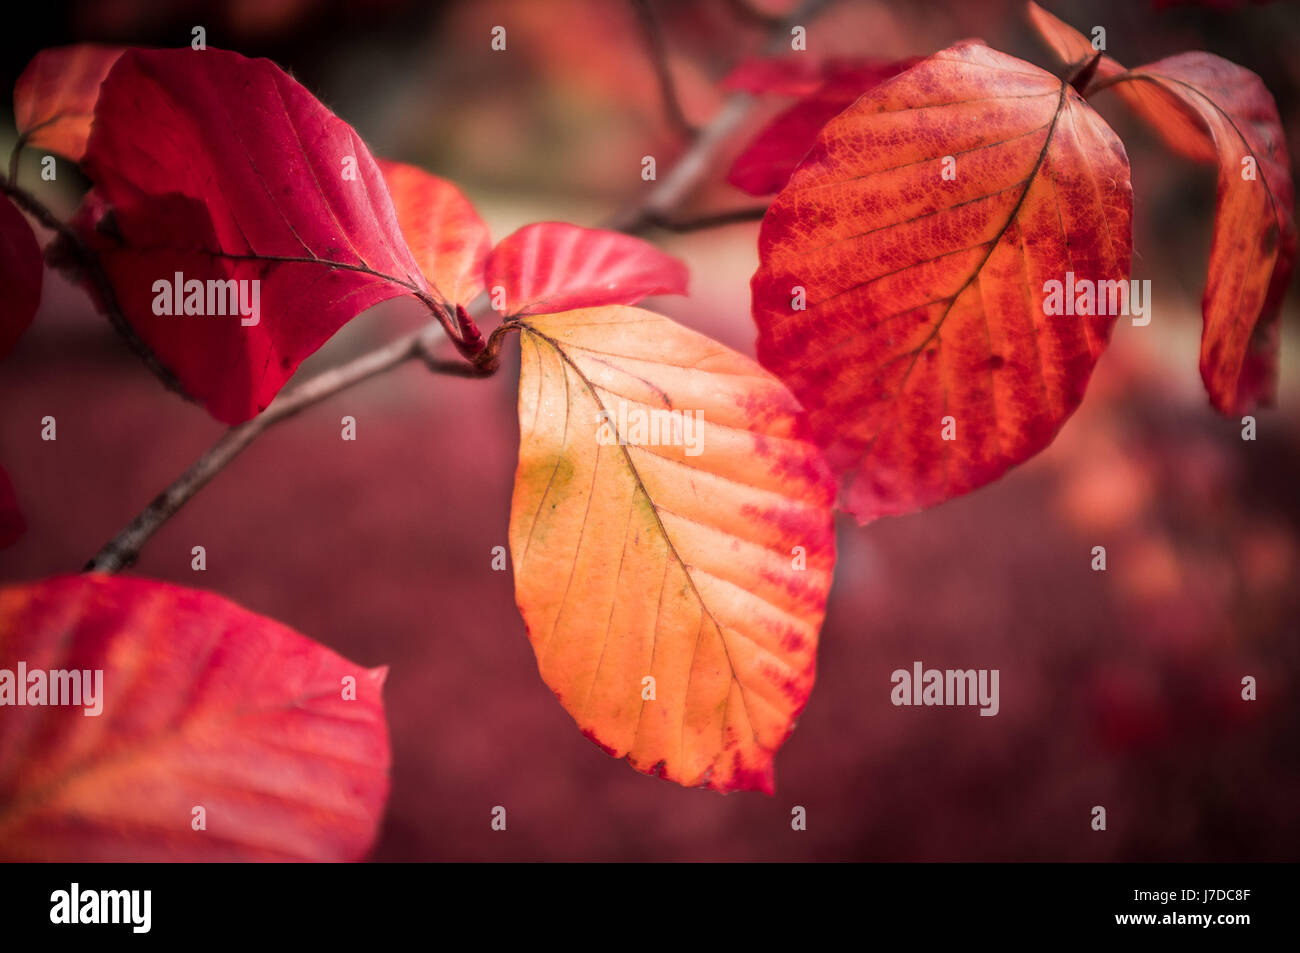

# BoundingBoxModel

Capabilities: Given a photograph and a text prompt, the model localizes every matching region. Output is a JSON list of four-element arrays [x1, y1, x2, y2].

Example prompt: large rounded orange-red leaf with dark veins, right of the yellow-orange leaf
[[751, 42, 1132, 521]]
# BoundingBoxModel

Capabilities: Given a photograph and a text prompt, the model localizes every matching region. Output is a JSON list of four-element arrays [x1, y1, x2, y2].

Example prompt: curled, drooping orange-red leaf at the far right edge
[[1030, 4, 1296, 416]]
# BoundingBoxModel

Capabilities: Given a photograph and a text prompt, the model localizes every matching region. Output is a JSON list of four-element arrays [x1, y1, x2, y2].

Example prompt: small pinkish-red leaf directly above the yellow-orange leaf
[[486, 222, 689, 315]]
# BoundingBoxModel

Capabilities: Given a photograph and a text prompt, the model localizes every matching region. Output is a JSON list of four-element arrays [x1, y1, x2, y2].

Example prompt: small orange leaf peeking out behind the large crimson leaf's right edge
[[376, 159, 491, 304]]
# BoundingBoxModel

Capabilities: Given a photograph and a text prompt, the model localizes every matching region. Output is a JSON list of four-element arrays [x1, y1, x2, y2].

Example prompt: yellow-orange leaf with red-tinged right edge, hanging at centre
[[510, 307, 835, 793]]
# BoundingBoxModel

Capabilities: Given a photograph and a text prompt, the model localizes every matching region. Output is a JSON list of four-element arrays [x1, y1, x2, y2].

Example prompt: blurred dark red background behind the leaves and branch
[[0, 0, 1300, 861]]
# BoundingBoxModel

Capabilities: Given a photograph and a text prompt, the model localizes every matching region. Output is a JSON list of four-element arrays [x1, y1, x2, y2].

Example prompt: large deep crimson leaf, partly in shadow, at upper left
[[85, 49, 429, 424]]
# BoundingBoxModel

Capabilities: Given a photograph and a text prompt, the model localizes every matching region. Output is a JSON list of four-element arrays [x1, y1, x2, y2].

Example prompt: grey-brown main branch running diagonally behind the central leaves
[[86, 0, 828, 572]]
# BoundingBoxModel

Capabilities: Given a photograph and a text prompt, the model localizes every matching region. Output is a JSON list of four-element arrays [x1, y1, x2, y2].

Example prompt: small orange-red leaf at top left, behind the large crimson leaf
[[13, 43, 125, 161]]
